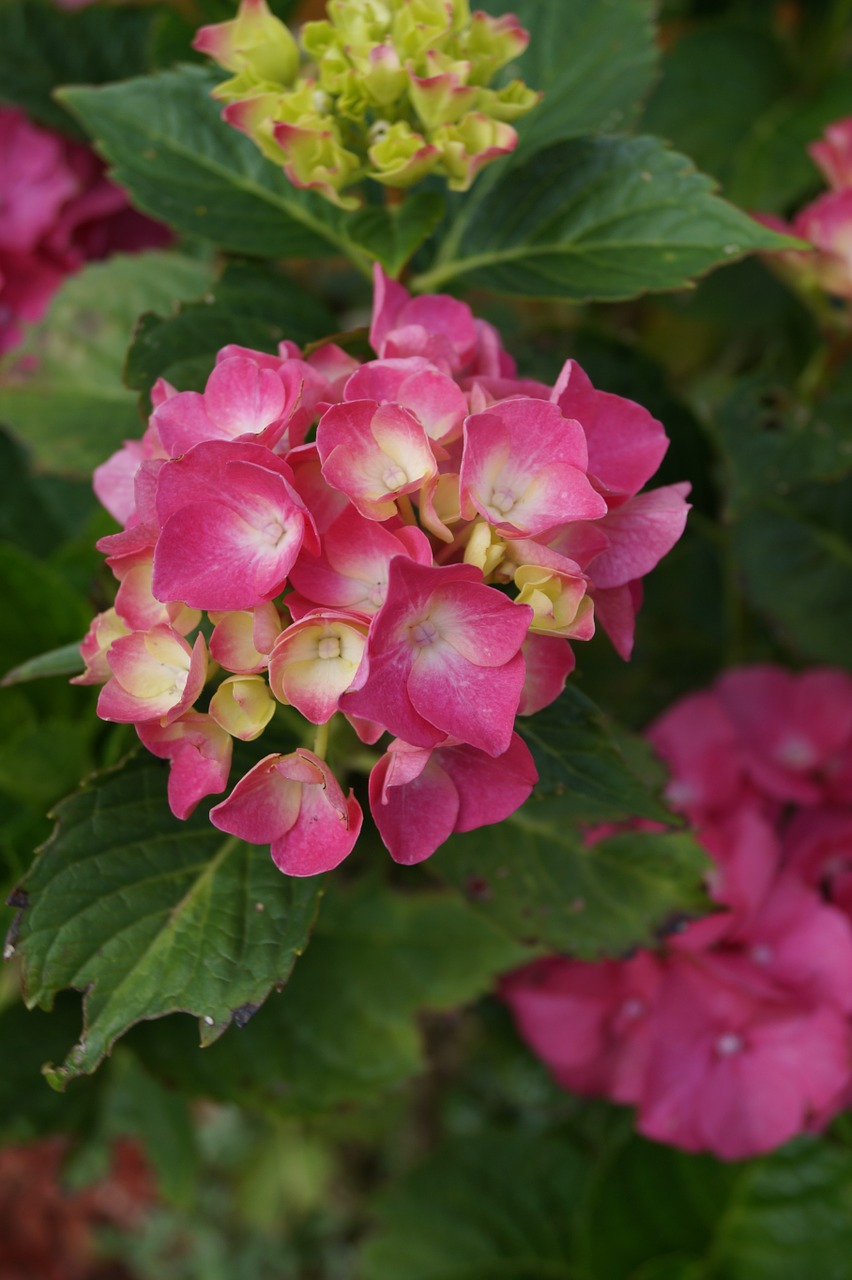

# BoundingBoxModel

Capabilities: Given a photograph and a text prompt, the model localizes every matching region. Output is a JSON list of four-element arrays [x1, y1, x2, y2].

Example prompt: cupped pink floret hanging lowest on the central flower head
[[210, 748, 363, 876]]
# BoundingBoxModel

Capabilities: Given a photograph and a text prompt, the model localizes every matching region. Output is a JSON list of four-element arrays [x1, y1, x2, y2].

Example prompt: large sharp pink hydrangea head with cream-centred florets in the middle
[[78, 269, 688, 876]]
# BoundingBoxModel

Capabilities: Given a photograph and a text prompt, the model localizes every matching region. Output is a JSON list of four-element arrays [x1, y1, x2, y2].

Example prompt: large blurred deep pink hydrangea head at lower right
[[503, 666, 852, 1160]]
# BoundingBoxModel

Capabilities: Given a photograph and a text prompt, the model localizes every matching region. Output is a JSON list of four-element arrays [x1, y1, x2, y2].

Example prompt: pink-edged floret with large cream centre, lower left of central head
[[97, 626, 207, 724]]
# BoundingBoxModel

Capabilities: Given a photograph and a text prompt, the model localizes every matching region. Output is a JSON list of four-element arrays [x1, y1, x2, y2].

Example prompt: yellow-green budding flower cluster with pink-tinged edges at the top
[[194, 0, 539, 209]]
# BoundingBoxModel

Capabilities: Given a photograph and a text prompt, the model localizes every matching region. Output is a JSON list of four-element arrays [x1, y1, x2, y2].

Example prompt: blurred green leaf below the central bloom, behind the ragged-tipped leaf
[[134, 881, 528, 1114]]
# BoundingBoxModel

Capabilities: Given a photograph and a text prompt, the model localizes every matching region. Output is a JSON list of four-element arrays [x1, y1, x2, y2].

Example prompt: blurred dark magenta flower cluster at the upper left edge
[[0, 106, 170, 353]]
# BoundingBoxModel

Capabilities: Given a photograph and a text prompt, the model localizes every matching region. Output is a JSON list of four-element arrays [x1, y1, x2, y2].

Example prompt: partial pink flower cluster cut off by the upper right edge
[[761, 118, 852, 312]]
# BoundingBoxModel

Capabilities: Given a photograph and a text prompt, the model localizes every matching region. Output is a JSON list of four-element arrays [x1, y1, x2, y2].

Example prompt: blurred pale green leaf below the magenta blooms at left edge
[[0, 252, 211, 475]]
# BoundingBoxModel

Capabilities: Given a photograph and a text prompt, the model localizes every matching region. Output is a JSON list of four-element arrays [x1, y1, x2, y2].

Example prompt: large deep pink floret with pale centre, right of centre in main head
[[340, 556, 532, 755]]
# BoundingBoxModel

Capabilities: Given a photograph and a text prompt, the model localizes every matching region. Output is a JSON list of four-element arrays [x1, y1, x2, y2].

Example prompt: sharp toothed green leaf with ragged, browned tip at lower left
[[11, 759, 320, 1088]]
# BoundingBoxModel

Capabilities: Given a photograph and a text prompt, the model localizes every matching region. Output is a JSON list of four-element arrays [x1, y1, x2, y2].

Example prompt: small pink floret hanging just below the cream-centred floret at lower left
[[136, 712, 233, 818]]
